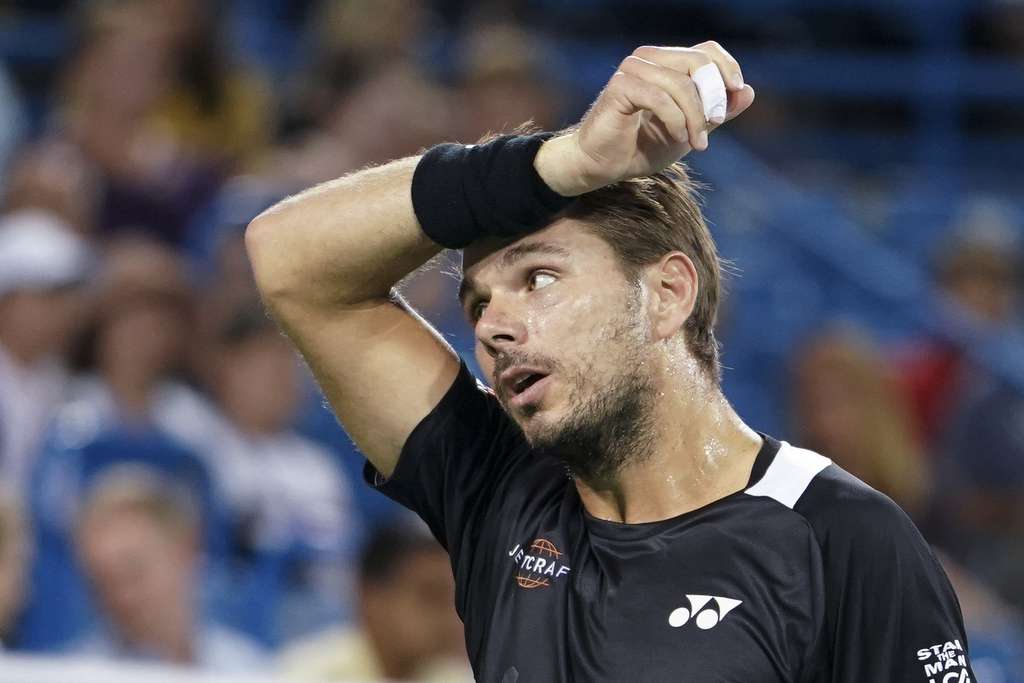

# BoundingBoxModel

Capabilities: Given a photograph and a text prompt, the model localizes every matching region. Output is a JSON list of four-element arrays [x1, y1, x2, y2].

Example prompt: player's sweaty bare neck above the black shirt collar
[[577, 368, 762, 523]]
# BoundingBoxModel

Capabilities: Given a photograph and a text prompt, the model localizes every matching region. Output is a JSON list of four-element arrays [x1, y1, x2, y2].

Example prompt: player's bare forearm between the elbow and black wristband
[[246, 158, 440, 309]]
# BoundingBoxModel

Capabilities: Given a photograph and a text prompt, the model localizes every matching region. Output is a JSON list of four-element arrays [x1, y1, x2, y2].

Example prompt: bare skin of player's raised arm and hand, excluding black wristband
[[246, 43, 754, 475]]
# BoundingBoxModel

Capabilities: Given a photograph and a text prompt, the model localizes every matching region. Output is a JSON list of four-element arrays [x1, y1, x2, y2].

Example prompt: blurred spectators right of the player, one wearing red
[[788, 225, 1024, 681]]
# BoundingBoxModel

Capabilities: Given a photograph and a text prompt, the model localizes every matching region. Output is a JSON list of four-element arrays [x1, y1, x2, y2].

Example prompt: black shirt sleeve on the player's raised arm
[[364, 364, 528, 565]]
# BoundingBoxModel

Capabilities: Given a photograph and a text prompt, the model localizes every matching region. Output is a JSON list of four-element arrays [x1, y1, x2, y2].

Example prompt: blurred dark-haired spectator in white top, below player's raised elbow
[[169, 304, 359, 644]]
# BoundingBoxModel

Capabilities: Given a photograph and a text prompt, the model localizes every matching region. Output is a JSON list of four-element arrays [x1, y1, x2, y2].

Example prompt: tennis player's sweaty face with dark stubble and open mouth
[[460, 219, 654, 477]]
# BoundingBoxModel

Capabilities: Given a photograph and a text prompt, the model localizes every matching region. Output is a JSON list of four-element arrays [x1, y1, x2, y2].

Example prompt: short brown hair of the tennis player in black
[[562, 163, 722, 381]]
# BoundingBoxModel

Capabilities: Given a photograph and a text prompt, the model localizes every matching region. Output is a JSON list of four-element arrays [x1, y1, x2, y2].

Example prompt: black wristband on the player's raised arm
[[413, 133, 574, 249]]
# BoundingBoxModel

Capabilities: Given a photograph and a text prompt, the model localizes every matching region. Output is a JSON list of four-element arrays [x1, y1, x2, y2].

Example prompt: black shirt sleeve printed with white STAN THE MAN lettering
[[798, 467, 974, 683]]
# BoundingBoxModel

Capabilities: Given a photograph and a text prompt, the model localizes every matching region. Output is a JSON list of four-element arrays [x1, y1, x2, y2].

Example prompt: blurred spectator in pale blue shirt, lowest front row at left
[[70, 464, 264, 673]]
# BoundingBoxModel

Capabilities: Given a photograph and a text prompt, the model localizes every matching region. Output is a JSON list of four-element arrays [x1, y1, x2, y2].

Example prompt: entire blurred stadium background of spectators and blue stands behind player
[[0, 0, 1024, 683]]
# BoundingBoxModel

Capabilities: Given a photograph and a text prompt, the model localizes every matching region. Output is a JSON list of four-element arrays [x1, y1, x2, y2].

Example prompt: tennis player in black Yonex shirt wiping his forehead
[[247, 43, 974, 683]]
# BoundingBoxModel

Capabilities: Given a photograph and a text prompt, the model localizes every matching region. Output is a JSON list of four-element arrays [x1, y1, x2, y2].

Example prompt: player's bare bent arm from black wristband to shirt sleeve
[[246, 154, 459, 474]]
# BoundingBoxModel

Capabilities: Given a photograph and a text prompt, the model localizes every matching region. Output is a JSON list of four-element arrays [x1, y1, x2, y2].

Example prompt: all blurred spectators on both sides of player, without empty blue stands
[[0, 0, 1024, 682]]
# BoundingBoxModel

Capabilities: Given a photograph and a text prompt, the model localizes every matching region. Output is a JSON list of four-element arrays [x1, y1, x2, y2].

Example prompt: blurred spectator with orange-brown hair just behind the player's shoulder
[[792, 327, 933, 518]]
